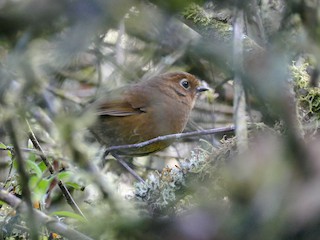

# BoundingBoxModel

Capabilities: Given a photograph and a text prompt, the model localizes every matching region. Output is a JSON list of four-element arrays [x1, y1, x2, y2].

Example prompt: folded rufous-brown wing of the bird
[[97, 87, 147, 117]]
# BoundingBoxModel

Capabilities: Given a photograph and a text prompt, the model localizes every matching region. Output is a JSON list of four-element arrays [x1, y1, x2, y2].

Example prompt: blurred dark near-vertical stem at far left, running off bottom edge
[[6, 120, 39, 240]]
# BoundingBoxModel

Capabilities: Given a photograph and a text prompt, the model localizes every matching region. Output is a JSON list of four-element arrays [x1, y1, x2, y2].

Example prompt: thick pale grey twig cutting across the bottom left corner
[[0, 189, 92, 240]]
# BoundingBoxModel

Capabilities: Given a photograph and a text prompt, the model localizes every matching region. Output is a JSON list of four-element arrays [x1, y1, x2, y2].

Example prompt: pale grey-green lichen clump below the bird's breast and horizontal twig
[[135, 135, 235, 215]]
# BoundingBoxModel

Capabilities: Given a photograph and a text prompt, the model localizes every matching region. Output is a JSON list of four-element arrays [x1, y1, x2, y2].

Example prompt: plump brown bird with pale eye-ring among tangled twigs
[[91, 72, 208, 156]]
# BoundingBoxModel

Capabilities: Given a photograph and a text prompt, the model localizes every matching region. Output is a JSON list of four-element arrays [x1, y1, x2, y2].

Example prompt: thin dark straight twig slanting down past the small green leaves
[[27, 122, 86, 219]]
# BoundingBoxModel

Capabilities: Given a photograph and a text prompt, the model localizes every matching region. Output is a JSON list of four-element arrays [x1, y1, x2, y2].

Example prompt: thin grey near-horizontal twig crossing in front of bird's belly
[[105, 126, 235, 153]]
